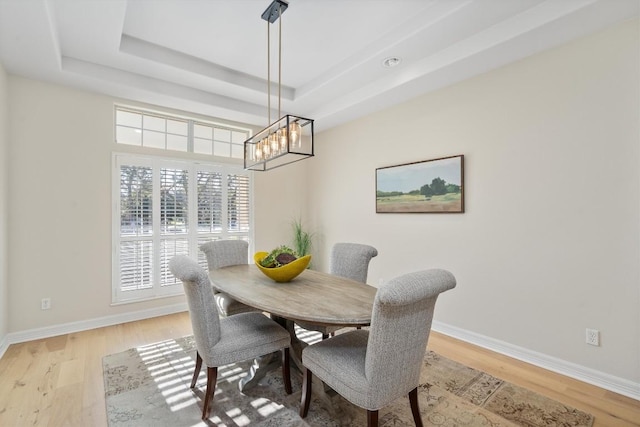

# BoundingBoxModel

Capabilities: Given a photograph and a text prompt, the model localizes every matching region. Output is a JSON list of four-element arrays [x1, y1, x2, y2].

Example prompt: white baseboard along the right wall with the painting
[[431, 320, 640, 400]]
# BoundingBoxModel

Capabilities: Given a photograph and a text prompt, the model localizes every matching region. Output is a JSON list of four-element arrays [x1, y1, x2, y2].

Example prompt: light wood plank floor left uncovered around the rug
[[0, 313, 640, 427]]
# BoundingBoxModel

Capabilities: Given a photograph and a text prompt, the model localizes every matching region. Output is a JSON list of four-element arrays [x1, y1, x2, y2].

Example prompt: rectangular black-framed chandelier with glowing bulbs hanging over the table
[[244, 0, 313, 171]]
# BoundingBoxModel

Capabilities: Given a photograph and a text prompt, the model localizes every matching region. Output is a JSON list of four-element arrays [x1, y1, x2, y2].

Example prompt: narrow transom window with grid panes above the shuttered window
[[115, 106, 250, 159]]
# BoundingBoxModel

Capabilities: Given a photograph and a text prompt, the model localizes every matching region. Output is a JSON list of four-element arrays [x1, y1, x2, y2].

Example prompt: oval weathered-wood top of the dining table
[[209, 264, 377, 326]]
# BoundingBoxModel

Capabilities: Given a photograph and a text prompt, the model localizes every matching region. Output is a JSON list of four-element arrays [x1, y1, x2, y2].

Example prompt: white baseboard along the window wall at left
[[0, 303, 188, 357]]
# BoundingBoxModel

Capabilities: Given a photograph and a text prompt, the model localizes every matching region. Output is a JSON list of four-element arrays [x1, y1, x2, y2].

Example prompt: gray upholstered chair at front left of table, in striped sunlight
[[169, 255, 291, 420]]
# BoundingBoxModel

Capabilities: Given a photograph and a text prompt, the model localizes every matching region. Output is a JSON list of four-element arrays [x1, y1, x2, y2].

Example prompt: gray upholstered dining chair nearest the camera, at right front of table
[[300, 270, 456, 427]]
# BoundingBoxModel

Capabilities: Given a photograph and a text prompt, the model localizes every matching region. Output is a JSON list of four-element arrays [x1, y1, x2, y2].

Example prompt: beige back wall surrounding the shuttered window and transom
[[3, 76, 294, 333]]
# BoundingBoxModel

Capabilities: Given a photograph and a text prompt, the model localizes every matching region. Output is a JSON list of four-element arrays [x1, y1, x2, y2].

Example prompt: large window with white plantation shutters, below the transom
[[113, 154, 251, 302]]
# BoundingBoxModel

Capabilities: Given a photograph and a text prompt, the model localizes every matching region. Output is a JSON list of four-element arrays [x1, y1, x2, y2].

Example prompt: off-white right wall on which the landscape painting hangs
[[309, 20, 640, 388]]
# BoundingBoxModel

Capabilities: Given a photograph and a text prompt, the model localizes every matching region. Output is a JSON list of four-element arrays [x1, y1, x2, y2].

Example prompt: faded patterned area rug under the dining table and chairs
[[103, 336, 593, 427]]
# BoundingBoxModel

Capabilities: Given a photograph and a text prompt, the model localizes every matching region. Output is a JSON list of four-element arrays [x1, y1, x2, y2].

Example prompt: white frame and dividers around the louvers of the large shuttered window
[[112, 153, 254, 305]]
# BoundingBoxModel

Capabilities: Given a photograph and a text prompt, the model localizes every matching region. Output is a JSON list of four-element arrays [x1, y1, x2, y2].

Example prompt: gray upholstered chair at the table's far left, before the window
[[200, 240, 259, 317]]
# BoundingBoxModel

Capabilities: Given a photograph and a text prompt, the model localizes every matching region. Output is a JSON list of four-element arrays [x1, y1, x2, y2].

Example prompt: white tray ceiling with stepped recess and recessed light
[[0, 0, 640, 130]]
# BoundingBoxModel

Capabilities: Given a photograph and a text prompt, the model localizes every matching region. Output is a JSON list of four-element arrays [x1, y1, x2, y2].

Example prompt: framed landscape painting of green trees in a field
[[376, 155, 464, 213]]
